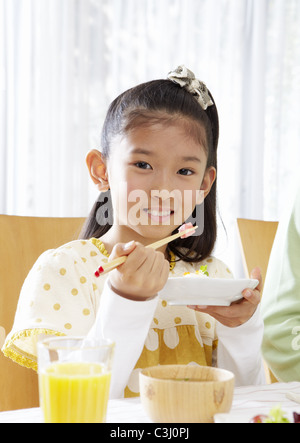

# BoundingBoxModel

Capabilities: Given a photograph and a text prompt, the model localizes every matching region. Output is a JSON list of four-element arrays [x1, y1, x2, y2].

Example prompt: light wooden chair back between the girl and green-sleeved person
[[237, 218, 278, 383]]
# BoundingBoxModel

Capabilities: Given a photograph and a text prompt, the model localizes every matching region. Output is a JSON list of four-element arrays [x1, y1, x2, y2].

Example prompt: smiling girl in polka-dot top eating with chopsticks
[[3, 66, 264, 397]]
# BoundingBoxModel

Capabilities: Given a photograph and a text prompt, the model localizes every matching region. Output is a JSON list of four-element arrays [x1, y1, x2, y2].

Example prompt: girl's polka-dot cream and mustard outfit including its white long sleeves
[[3, 239, 263, 398]]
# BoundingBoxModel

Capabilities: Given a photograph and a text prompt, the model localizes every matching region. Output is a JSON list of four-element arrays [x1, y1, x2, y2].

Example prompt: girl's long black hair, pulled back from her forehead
[[81, 80, 219, 262]]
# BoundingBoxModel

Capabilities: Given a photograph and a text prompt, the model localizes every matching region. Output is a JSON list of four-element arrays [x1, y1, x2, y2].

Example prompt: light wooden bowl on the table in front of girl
[[140, 365, 234, 423]]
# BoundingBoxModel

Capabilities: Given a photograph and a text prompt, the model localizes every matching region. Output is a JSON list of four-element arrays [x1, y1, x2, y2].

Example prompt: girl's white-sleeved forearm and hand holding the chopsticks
[[89, 242, 169, 398]]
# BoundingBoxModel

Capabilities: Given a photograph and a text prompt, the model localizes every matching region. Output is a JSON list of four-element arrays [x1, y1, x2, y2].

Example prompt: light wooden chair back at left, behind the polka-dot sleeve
[[0, 215, 85, 411]]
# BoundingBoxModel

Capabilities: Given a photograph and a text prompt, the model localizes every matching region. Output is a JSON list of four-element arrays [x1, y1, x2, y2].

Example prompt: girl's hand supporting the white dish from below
[[189, 268, 262, 328]]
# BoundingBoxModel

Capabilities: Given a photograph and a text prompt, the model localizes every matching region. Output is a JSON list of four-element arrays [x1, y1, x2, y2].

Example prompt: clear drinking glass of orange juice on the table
[[38, 337, 114, 423]]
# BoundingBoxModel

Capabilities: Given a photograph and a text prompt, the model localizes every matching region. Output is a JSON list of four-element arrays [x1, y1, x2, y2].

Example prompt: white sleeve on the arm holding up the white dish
[[217, 308, 266, 386]]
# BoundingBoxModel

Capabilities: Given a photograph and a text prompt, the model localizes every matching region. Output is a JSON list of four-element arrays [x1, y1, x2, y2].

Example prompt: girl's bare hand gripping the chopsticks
[[109, 241, 169, 300]]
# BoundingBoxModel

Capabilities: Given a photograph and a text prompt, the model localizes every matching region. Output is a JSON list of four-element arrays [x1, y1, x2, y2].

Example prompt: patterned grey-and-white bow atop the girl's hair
[[168, 65, 214, 111]]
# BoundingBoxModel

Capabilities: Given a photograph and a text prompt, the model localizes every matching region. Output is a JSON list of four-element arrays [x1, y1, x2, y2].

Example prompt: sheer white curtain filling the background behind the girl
[[0, 0, 300, 276]]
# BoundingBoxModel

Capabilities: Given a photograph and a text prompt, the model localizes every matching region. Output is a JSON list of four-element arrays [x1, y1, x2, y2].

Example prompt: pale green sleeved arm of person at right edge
[[262, 186, 300, 382]]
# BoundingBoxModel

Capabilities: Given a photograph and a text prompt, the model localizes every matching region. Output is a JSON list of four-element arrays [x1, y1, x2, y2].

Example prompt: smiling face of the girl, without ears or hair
[[106, 121, 216, 243]]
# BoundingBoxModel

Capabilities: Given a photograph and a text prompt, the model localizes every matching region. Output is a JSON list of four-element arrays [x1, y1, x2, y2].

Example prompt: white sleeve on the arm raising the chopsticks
[[88, 281, 158, 398]]
